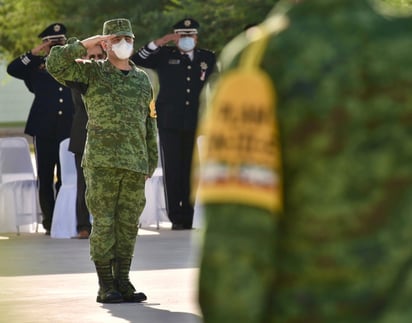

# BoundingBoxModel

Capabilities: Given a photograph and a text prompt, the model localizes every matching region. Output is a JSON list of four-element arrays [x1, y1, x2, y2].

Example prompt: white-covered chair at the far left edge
[[0, 137, 41, 234]]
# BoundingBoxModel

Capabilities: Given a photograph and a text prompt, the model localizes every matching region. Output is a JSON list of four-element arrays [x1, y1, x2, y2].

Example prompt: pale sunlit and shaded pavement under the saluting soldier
[[0, 228, 202, 323]]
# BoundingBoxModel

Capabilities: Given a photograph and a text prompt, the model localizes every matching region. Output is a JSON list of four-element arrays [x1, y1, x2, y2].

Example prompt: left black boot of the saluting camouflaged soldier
[[94, 261, 123, 303]]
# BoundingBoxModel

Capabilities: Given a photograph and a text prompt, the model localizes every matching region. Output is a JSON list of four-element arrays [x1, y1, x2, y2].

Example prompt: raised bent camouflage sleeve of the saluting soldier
[[46, 38, 88, 85]]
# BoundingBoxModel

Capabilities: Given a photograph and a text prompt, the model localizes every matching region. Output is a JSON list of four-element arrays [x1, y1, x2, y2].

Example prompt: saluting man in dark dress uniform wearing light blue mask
[[131, 18, 216, 230]]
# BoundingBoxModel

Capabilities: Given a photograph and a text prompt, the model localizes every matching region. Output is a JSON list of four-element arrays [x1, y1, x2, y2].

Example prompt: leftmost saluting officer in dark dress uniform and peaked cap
[[7, 23, 73, 234]]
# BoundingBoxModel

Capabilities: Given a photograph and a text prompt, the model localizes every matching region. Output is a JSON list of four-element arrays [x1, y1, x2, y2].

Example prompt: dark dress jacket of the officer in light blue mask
[[131, 45, 216, 130]]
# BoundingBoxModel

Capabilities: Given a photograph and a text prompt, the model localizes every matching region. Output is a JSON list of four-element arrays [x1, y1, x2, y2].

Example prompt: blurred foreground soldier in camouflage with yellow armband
[[199, 0, 412, 323]]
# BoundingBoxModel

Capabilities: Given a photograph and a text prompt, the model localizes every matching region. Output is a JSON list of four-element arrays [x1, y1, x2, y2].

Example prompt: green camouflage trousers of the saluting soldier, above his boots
[[84, 167, 146, 261]]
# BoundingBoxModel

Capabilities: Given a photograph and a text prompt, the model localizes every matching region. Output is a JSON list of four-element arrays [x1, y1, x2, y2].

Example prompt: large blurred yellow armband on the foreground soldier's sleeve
[[197, 25, 286, 212]]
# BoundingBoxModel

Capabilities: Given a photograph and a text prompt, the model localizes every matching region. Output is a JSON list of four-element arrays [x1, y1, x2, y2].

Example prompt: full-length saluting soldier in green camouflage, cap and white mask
[[47, 19, 157, 303]]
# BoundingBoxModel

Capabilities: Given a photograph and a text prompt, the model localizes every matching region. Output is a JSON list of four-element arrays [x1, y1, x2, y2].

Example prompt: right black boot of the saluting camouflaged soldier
[[113, 258, 147, 303]]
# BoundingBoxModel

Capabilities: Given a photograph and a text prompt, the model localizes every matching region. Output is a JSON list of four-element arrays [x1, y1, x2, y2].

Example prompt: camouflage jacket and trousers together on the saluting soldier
[[47, 39, 158, 262]]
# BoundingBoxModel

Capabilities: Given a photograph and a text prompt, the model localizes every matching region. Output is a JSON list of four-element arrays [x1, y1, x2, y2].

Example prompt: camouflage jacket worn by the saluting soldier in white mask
[[47, 38, 158, 180]]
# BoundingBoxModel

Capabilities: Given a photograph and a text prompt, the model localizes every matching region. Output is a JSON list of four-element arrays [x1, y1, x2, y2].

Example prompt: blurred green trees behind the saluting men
[[0, 0, 412, 61]]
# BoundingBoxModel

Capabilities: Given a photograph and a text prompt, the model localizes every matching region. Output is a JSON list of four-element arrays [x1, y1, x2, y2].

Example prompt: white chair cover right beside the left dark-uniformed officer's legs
[[50, 138, 77, 239]]
